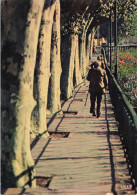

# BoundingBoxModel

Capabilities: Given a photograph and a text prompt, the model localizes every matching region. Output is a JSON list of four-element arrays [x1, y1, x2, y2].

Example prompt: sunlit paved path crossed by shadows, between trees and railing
[[5, 82, 135, 195]]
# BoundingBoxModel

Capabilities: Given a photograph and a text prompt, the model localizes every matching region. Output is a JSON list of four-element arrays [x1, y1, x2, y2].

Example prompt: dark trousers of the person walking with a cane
[[90, 92, 103, 115]]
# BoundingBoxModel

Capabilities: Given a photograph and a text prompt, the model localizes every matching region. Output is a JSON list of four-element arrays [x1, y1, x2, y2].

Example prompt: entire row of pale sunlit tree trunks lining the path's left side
[[1, 0, 95, 187]]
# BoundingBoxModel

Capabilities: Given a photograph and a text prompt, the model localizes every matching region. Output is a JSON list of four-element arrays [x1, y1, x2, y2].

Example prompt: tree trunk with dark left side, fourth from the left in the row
[[61, 34, 76, 99]]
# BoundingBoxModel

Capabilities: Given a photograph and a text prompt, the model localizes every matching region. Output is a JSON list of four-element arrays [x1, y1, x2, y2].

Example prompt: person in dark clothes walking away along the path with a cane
[[87, 62, 108, 118]]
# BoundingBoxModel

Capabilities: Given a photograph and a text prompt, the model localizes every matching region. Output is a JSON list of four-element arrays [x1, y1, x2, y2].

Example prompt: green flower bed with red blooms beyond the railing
[[118, 49, 137, 107]]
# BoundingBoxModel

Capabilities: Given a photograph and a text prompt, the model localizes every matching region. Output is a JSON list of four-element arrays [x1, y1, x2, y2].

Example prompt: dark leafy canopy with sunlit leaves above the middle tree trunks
[[61, 0, 100, 35]]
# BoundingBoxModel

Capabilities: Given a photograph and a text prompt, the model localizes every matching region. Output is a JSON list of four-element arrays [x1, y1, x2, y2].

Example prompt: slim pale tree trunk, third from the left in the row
[[48, 0, 61, 114]]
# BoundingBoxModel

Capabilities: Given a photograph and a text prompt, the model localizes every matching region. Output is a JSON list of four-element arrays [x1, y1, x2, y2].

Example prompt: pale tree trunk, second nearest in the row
[[32, 0, 56, 138]]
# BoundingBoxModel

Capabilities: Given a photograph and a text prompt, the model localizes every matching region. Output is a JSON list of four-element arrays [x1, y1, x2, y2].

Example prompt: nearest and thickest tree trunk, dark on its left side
[[2, 0, 44, 187]]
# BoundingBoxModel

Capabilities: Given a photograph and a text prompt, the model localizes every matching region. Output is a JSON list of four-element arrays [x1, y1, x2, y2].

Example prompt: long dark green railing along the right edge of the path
[[107, 67, 137, 190]]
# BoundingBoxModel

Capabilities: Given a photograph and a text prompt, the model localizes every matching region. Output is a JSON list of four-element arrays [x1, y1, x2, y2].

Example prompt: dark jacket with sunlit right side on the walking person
[[87, 66, 108, 94]]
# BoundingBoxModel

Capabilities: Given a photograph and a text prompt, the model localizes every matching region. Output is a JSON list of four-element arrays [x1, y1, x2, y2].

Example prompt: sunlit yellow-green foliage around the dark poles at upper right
[[91, 0, 137, 39]]
